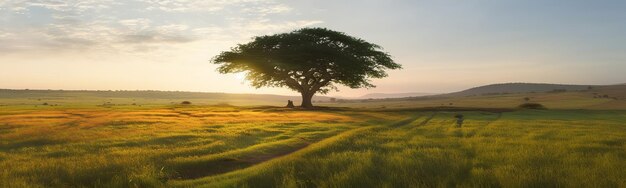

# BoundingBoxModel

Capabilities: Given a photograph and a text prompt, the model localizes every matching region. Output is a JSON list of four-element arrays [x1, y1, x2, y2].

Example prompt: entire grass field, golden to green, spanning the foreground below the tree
[[0, 90, 626, 187]]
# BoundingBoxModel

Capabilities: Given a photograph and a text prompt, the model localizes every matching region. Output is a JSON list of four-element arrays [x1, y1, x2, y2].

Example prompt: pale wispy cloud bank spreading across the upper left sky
[[0, 0, 322, 54]]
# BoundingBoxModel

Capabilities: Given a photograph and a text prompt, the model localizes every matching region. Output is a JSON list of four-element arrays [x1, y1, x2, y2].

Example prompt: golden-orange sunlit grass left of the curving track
[[0, 106, 362, 187]]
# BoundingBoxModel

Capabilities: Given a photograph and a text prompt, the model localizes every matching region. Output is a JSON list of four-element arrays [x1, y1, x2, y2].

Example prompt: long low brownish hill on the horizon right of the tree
[[336, 83, 626, 110]]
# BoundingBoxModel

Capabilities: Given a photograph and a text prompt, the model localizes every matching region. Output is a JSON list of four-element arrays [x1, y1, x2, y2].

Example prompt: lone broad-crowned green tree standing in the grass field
[[211, 28, 401, 108]]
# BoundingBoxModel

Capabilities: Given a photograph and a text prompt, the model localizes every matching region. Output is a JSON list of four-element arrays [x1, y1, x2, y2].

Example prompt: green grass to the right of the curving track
[[174, 111, 626, 187]]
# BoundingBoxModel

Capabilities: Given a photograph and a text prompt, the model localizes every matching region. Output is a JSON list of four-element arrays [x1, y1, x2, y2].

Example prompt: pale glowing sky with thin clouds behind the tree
[[0, 0, 626, 97]]
